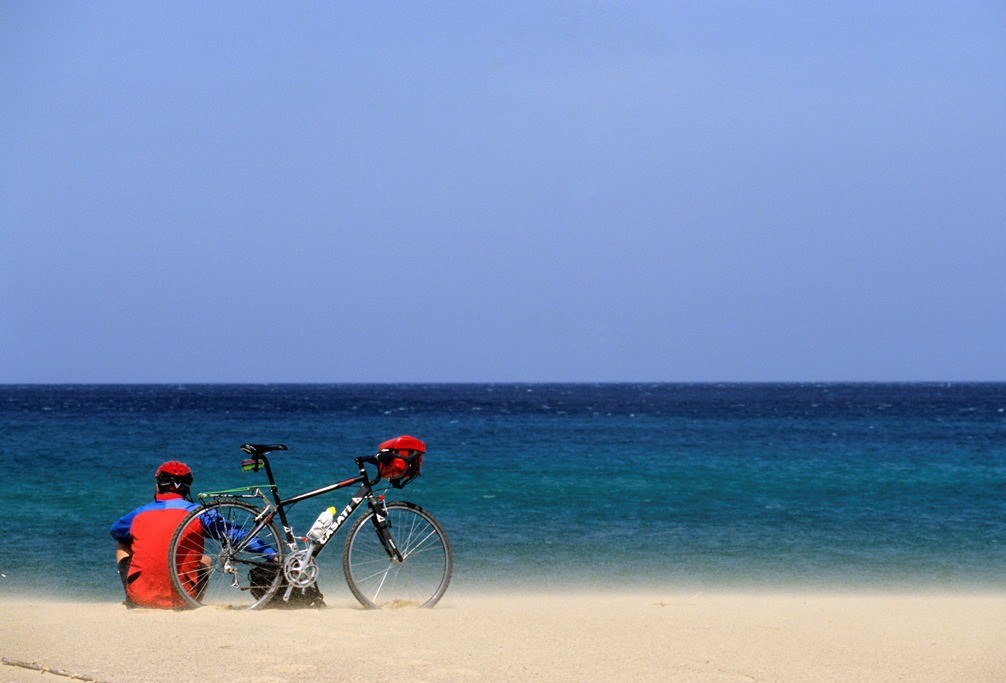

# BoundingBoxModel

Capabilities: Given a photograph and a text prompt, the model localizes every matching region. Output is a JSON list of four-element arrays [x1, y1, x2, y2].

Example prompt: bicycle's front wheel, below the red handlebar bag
[[342, 501, 454, 610]]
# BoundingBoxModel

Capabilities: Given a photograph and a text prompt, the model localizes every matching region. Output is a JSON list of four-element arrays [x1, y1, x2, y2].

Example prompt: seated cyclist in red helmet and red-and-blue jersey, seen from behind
[[109, 460, 197, 609]]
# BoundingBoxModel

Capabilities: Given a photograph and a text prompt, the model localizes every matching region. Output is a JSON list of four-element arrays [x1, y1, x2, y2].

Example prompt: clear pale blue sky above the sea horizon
[[0, 1, 1006, 382]]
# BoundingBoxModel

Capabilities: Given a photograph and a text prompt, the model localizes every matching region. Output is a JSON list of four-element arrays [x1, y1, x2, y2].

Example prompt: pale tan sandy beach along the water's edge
[[0, 592, 1006, 683]]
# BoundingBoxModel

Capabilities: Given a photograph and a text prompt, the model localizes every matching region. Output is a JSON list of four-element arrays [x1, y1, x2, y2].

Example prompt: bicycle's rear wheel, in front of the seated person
[[168, 501, 284, 610]]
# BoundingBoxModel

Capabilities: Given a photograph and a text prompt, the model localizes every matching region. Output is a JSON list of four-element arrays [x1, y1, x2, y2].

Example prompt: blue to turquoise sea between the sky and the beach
[[0, 384, 1006, 600]]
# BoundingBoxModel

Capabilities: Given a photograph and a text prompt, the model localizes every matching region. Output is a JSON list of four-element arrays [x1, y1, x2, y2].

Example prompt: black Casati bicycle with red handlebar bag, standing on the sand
[[168, 437, 454, 610]]
